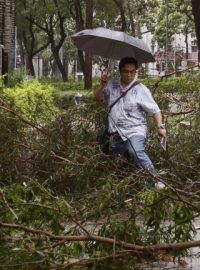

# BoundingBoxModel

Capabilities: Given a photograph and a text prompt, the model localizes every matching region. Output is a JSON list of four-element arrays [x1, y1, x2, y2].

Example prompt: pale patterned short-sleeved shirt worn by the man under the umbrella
[[104, 80, 160, 141]]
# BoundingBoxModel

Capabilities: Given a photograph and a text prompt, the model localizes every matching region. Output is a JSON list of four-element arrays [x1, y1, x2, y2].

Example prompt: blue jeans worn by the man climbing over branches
[[109, 134, 155, 172]]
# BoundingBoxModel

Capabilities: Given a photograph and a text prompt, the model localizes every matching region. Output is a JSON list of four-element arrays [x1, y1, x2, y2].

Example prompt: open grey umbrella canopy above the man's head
[[72, 27, 155, 63]]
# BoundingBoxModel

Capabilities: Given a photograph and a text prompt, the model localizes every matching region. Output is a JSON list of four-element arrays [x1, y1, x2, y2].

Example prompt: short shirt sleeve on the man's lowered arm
[[137, 85, 160, 115]]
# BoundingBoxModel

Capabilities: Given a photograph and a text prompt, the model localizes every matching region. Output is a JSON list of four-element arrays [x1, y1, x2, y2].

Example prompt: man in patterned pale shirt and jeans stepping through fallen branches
[[93, 57, 166, 176]]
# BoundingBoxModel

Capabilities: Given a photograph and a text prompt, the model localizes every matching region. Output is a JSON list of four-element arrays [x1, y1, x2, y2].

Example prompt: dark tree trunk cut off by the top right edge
[[191, 0, 200, 63]]
